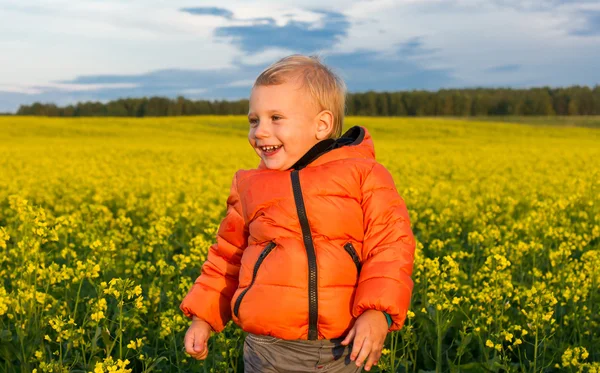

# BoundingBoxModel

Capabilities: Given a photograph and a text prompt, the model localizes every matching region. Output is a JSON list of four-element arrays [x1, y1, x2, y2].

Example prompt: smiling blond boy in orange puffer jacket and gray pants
[[180, 55, 415, 372]]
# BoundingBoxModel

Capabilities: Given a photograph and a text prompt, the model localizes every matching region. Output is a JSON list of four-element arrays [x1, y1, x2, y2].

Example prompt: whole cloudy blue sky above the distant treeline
[[0, 0, 600, 112]]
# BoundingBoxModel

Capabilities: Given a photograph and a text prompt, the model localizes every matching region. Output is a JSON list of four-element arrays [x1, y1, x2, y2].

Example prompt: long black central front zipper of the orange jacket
[[291, 170, 319, 340]]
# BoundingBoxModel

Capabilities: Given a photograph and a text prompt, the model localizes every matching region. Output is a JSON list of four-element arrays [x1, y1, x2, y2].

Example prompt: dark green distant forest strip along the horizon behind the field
[[12, 85, 600, 117]]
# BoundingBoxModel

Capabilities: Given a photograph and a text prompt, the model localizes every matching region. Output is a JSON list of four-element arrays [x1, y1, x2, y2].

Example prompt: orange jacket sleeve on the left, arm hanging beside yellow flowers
[[179, 173, 248, 332]]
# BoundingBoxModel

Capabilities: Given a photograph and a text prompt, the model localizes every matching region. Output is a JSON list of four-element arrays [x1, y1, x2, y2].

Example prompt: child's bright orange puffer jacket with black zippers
[[180, 126, 415, 340]]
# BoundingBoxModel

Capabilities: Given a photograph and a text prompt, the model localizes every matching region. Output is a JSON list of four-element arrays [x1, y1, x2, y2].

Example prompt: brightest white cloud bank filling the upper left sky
[[0, 1, 238, 85]]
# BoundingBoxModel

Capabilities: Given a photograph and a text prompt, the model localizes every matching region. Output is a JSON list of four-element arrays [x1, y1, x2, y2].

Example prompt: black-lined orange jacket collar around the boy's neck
[[258, 126, 375, 170]]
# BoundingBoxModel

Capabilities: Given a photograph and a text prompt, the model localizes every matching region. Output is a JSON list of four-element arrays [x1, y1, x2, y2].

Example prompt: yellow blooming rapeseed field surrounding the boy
[[0, 117, 600, 373]]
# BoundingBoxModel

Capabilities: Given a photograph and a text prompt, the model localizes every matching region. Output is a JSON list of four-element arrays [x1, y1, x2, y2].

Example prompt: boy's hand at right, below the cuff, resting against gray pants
[[342, 310, 388, 371]]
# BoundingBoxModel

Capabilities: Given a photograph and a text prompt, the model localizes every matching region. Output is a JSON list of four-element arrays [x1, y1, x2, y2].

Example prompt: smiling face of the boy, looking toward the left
[[248, 80, 327, 170]]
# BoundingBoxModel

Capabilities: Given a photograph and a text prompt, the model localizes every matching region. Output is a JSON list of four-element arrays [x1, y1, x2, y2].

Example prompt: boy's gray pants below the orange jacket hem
[[244, 333, 362, 373]]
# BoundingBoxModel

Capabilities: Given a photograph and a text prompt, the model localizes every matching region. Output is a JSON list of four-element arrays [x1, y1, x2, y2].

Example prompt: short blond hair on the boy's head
[[252, 54, 346, 139]]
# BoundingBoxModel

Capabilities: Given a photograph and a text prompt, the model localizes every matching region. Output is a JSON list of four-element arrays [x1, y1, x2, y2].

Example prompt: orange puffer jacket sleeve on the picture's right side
[[352, 163, 415, 331]]
